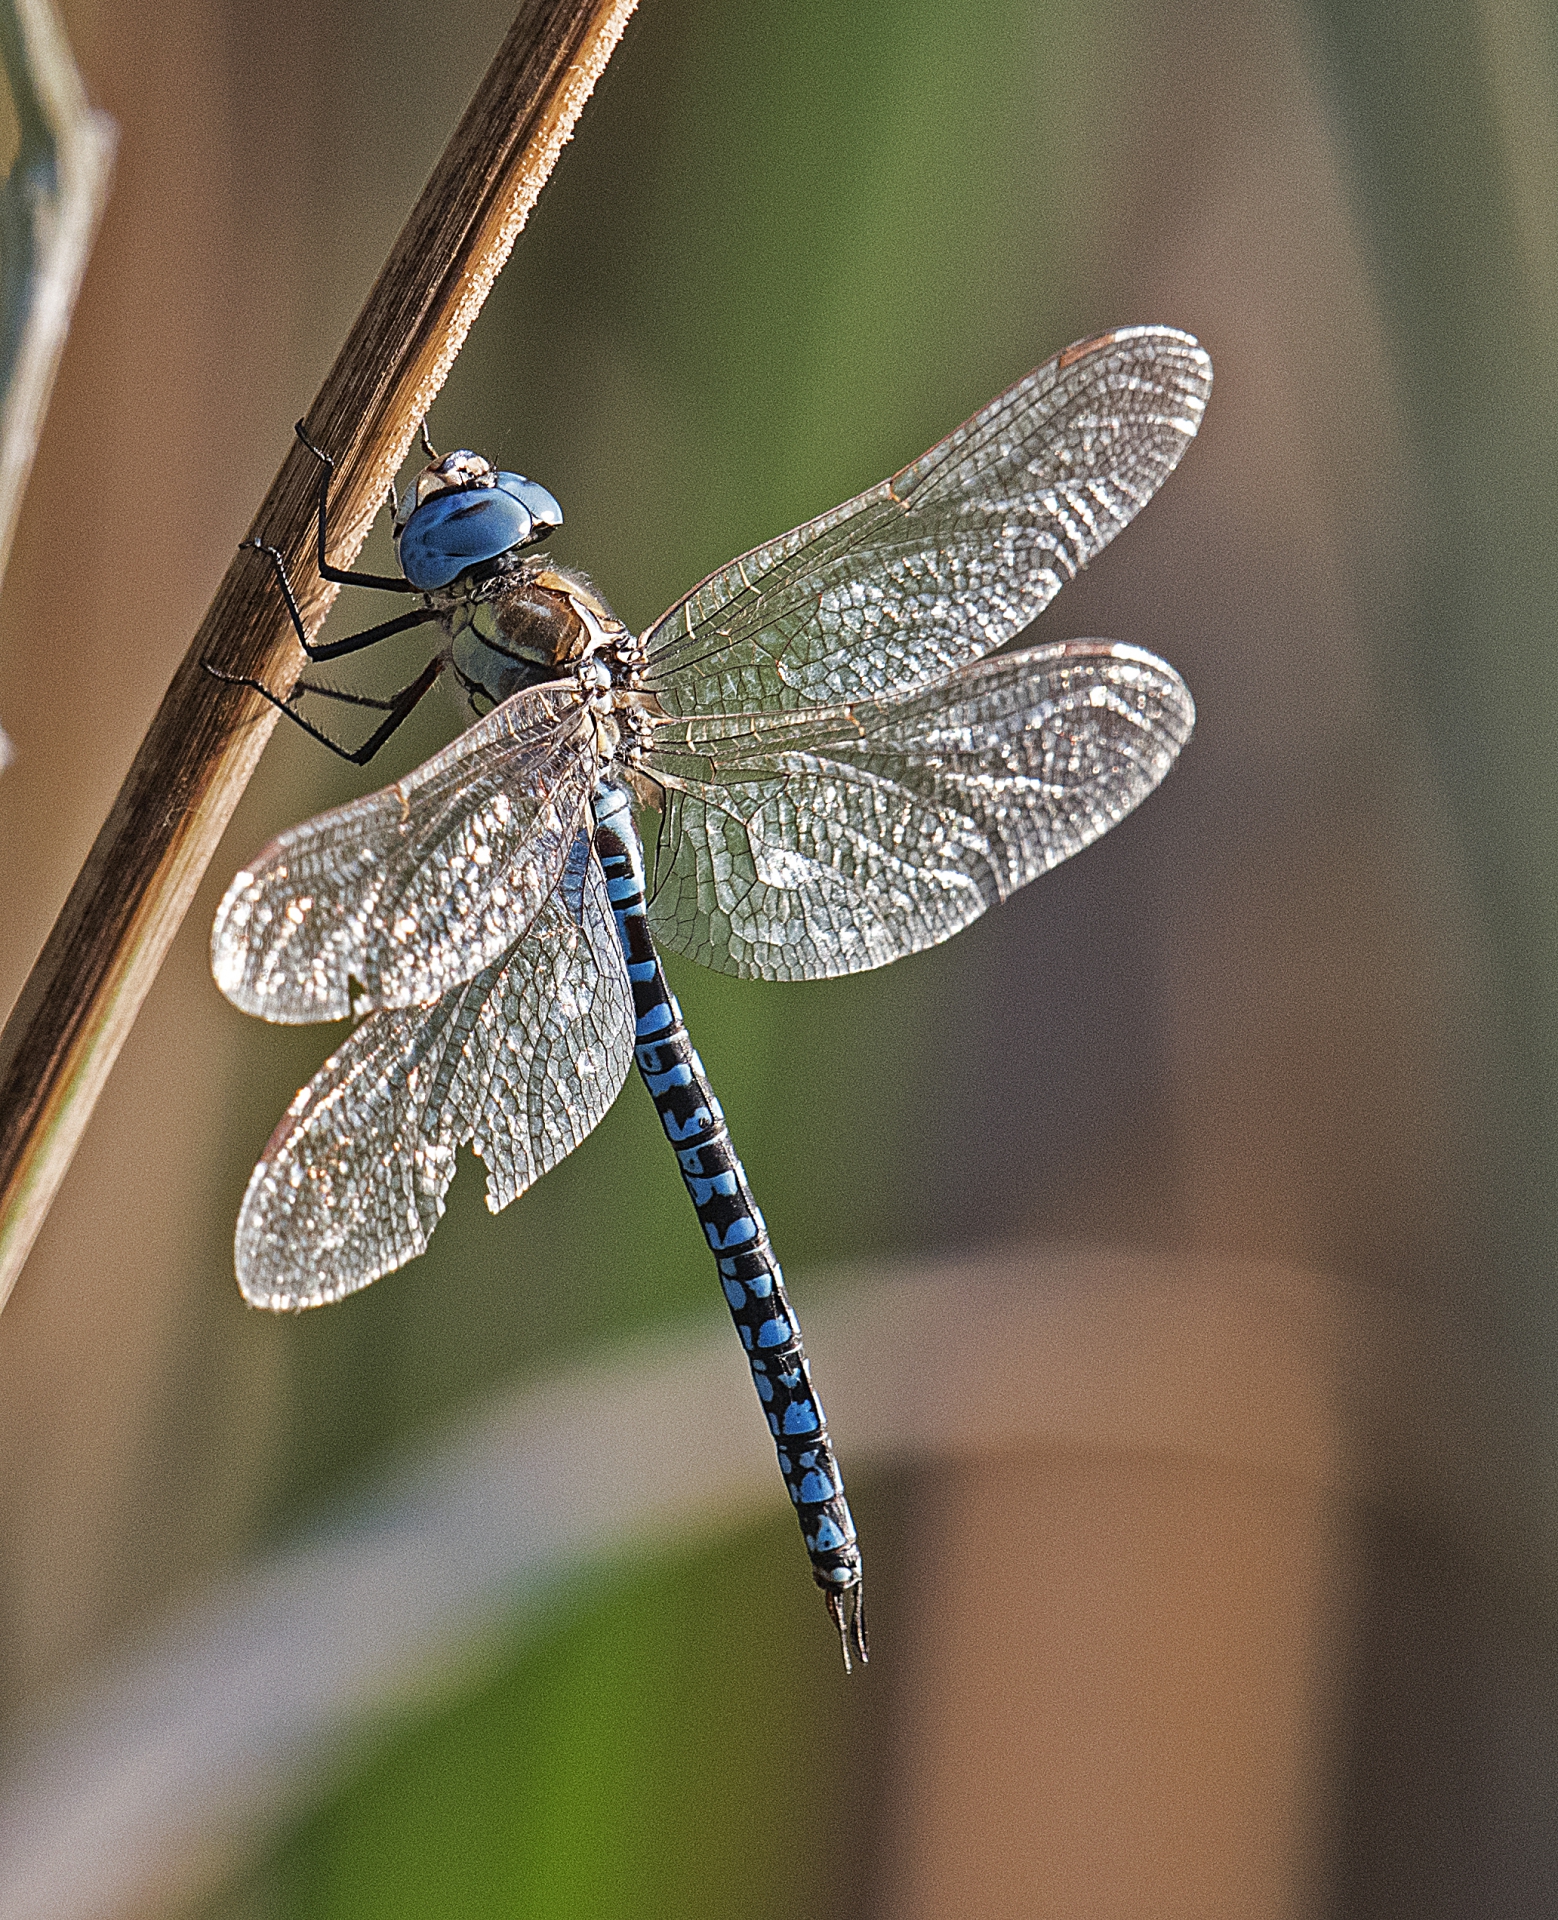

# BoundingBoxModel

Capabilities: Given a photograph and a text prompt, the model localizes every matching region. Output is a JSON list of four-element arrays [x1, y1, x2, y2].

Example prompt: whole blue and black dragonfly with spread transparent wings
[[211, 326, 1212, 1667]]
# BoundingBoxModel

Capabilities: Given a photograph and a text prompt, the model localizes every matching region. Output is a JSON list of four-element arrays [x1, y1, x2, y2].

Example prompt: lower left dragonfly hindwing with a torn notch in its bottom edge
[[236, 860, 632, 1308]]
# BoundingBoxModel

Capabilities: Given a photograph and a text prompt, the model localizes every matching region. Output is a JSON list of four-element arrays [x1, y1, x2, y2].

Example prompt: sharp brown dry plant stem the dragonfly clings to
[[0, 0, 634, 1304]]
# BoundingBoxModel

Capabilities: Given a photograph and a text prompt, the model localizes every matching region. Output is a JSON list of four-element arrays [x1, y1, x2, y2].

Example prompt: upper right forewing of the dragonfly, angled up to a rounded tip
[[644, 326, 1212, 716]]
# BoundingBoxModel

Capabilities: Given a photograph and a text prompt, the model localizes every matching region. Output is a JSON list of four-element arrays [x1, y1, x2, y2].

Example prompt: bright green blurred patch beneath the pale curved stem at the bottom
[[275, 1515, 876, 1920]]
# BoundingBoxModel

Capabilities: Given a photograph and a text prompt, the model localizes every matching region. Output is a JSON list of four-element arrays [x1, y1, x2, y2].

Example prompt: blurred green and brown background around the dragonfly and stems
[[0, 0, 1558, 1920]]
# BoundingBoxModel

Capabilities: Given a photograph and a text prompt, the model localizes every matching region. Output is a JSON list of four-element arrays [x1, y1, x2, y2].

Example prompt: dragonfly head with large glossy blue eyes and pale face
[[396, 449, 563, 593]]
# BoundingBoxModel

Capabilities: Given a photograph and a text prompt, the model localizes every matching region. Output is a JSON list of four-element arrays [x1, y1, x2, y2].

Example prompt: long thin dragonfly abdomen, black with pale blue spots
[[594, 785, 866, 1661]]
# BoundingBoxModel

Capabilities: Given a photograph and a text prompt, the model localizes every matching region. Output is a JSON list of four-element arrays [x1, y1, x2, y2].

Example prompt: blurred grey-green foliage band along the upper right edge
[[1314, 0, 1558, 1359]]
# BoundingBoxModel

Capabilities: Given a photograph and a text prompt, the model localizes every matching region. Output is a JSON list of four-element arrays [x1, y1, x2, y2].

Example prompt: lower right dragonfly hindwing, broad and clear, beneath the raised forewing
[[649, 639, 1195, 979]]
